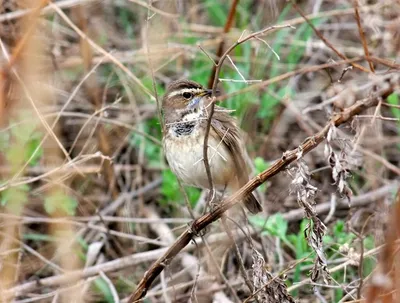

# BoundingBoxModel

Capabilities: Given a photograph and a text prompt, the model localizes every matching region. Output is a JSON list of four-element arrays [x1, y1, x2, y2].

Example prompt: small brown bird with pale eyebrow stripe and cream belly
[[162, 80, 262, 214]]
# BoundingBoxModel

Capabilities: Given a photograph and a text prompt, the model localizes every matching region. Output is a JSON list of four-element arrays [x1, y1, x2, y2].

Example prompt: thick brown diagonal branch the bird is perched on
[[128, 76, 400, 303]]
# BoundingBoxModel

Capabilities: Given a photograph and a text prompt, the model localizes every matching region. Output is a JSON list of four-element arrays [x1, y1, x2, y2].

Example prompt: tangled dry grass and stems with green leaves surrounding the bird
[[0, 0, 400, 302]]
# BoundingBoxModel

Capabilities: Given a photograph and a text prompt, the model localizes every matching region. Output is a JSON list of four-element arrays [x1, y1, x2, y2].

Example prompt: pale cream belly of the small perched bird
[[164, 128, 236, 190]]
